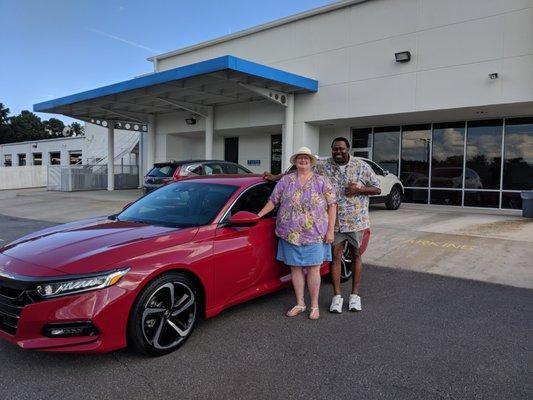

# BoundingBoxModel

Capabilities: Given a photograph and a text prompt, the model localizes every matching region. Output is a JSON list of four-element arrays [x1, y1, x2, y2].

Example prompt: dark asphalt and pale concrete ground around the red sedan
[[0, 189, 533, 399]]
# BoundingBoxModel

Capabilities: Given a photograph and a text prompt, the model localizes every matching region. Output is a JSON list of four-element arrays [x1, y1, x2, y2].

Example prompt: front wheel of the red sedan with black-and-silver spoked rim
[[128, 272, 200, 357]]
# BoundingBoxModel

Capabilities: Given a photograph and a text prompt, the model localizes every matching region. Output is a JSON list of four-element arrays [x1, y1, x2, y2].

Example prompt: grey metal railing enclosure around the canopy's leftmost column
[[47, 165, 139, 192]]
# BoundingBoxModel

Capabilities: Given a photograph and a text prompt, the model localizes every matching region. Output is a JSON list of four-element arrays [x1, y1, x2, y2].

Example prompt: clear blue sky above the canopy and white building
[[0, 0, 336, 123]]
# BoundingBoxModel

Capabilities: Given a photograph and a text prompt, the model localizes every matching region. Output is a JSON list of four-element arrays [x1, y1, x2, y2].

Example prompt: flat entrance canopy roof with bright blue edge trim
[[33, 55, 318, 123]]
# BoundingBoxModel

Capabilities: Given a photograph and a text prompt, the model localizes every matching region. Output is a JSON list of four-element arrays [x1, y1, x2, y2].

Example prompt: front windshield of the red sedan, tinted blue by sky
[[117, 181, 237, 228]]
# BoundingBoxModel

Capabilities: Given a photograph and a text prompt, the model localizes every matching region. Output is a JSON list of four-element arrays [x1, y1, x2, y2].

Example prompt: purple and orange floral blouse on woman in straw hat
[[270, 172, 337, 246]]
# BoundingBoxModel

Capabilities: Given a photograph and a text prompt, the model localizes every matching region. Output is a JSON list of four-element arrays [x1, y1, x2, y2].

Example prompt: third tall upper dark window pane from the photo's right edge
[[431, 122, 464, 189]]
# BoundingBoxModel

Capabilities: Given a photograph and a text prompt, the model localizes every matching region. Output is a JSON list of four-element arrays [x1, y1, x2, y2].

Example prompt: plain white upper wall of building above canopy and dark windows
[[157, 0, 533, 123]]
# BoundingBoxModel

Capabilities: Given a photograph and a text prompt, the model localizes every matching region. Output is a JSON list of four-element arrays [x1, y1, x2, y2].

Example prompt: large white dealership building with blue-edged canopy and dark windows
[[34, 0, 533, 208]]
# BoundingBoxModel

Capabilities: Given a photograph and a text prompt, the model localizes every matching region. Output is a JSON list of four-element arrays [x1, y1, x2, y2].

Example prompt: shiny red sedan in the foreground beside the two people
[[0, 175, 368, 355]]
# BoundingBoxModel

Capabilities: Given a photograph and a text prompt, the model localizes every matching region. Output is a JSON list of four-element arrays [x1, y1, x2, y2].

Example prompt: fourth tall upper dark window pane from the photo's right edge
[[401, 125, 431, 187]]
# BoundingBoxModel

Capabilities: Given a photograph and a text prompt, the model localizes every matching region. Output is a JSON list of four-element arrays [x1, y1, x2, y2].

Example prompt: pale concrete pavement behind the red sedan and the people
[[0, 189, 533, 288]]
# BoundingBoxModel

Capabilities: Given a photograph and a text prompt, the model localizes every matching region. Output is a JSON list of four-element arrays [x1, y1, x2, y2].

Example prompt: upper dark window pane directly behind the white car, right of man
[[372, 126, 400, 176]]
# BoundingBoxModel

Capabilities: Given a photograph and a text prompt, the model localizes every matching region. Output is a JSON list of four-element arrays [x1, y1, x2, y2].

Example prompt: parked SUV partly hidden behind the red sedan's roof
[[143, 160, 252, 193]]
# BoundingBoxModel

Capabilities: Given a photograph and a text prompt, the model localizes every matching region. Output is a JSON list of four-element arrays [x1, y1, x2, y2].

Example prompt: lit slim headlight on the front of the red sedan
[[37, 268, 130, 298]]
